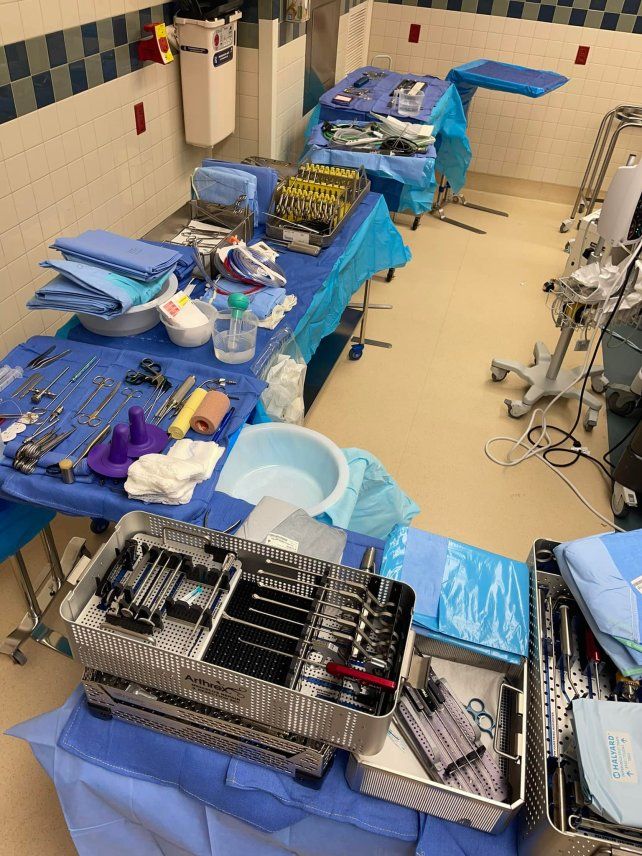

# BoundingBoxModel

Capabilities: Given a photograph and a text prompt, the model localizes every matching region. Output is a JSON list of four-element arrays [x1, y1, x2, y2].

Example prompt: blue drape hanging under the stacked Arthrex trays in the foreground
[[9, 689, 517, 856]]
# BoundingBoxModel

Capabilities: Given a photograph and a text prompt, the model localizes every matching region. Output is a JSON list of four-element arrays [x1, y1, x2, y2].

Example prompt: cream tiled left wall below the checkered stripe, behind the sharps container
[[0, 48, 258, 353]]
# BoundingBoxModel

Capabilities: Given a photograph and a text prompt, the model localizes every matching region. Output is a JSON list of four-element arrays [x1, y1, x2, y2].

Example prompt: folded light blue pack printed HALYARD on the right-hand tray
[[573, 698, 642, 829]]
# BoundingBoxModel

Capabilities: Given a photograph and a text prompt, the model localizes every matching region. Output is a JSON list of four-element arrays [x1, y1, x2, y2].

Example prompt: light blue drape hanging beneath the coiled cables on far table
[[303, 125, 437, 214]]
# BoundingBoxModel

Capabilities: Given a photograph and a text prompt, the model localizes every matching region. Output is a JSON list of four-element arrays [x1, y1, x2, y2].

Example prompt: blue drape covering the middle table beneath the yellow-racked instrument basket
[[61, 193, 411, 370]]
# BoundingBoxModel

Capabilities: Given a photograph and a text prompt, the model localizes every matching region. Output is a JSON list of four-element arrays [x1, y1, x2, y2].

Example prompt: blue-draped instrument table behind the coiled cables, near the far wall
[[308, 66, 471, 197]]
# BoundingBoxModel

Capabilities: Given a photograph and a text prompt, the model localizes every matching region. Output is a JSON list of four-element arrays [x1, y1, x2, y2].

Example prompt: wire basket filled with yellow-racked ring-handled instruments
[[266, 163, 370, 247]]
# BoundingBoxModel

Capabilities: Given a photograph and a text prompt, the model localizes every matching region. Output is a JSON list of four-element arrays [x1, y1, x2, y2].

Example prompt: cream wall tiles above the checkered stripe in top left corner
[[0, 0, 162, 45]]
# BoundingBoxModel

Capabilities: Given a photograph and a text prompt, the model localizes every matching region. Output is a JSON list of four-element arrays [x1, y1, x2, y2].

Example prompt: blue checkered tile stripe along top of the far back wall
[[372, 0, 642, 34]]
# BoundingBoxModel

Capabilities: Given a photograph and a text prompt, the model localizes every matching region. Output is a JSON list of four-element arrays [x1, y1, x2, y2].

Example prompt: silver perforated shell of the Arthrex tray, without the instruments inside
[[61, 511, 414, 753]]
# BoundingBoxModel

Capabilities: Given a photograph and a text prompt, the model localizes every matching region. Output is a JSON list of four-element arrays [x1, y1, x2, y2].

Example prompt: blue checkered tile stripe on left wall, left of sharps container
[[0, 0, 175, 124]]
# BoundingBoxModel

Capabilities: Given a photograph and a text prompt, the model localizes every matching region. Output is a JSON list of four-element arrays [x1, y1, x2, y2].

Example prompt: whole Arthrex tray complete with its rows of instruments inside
[[61, 512, 414, 751]]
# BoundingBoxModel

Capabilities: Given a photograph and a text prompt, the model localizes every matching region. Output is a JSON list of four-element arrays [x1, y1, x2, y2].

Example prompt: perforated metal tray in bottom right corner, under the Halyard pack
[[519, 539, 642, 856]]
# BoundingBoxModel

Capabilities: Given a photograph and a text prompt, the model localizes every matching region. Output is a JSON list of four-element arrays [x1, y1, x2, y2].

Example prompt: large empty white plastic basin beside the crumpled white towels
[[216, 422, 349, 517]]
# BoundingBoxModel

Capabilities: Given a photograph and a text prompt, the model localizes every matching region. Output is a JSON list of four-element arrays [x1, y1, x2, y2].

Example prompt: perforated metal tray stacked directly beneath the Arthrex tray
[[82, 669, 334, 778]]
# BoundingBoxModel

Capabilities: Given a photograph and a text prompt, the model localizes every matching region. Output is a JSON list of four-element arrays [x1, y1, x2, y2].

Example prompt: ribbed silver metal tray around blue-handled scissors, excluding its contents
[[347, 635, 524, 832]]
